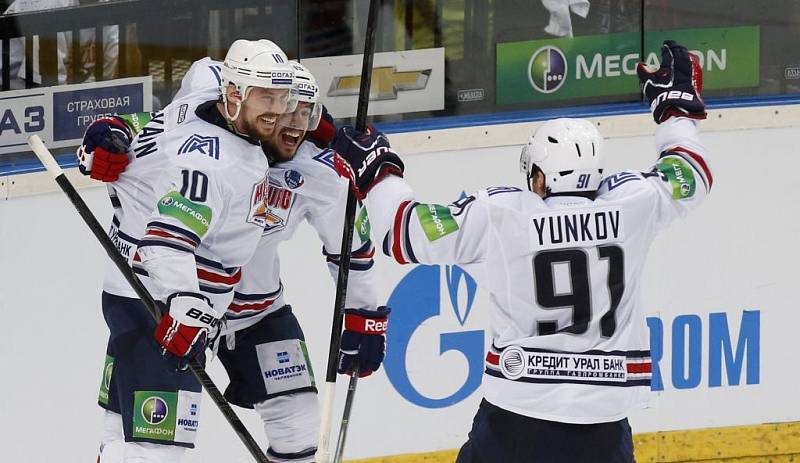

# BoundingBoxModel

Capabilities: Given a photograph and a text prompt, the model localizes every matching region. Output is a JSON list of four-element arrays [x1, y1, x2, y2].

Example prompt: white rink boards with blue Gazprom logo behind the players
[[0, 121, 800, 462]]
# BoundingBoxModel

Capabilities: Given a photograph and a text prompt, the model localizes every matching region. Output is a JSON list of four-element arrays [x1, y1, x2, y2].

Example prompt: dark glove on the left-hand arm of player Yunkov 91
[[333, 126, 404, 199]]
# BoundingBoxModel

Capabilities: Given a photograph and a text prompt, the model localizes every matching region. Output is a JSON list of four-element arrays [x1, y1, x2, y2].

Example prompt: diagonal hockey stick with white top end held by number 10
[[28, 135, 269, 463]]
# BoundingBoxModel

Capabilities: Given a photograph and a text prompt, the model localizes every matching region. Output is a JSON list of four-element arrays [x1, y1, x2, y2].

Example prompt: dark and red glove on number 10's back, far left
[[77, 116, 133, 182]]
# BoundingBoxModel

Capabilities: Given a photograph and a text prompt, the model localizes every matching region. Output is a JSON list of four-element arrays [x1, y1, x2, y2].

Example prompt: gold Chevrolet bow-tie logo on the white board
[[328, 66, 432, 101]]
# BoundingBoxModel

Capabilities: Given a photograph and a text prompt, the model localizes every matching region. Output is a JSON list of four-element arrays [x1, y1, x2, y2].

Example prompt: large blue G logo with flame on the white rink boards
[[384, 265, 484, 408]]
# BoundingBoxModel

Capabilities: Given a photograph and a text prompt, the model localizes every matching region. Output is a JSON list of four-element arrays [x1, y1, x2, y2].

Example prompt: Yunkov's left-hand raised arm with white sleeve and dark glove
[[334, 127, 490, 264]]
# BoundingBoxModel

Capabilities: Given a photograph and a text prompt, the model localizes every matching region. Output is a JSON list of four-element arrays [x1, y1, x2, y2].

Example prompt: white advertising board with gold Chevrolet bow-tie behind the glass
[[300, 48, 444, 118]]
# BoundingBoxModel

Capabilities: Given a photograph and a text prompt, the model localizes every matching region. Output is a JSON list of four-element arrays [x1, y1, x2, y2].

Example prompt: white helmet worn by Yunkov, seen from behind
[[519, 118, 603, 194]]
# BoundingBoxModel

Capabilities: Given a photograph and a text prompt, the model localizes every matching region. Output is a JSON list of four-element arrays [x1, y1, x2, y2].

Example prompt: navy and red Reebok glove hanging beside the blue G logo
[[337, 306, 392, 378]]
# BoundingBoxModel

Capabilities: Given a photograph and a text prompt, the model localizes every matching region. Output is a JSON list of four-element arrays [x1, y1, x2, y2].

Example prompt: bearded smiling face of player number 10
[[237, 87, 289, 140]]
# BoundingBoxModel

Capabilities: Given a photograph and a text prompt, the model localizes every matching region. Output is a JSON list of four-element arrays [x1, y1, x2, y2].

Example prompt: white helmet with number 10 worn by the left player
[[220, 39, 296, 121]]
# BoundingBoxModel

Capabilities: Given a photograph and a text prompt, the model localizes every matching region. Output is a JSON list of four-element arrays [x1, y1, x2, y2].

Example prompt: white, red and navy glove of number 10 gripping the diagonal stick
[[154, 293, 219, 369]]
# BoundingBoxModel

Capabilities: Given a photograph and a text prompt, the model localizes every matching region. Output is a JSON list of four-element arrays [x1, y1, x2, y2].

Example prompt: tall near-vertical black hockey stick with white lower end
[[316, 0, 381, 463]]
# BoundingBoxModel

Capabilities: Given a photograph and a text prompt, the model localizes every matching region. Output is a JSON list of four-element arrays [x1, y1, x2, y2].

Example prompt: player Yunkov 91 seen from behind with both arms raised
[[334, 41, 712, 463]]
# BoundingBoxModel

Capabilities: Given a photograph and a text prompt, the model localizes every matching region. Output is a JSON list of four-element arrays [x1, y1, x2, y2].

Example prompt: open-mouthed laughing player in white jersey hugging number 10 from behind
[[86, 58, 388, 462]]
